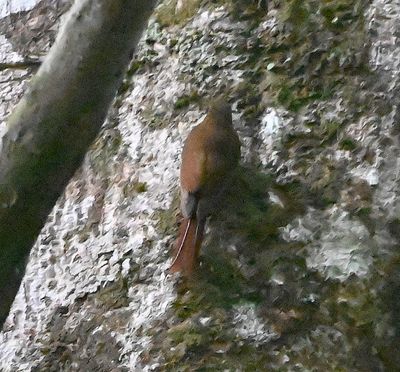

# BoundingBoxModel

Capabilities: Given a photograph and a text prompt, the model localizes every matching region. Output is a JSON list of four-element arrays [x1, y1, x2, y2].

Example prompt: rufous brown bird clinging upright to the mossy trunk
[[171, 99, 240, 277]]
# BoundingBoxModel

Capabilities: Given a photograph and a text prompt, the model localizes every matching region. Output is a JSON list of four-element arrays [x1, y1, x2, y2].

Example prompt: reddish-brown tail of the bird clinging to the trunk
[[170, 218, 205, 277]]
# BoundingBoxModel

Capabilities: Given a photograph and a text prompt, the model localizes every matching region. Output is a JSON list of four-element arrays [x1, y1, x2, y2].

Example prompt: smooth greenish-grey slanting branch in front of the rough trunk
[[0, 0, 156, 327]]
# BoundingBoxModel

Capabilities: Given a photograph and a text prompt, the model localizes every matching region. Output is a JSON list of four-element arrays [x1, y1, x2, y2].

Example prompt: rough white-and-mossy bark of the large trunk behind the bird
[[0, 0, 400, 372]]
